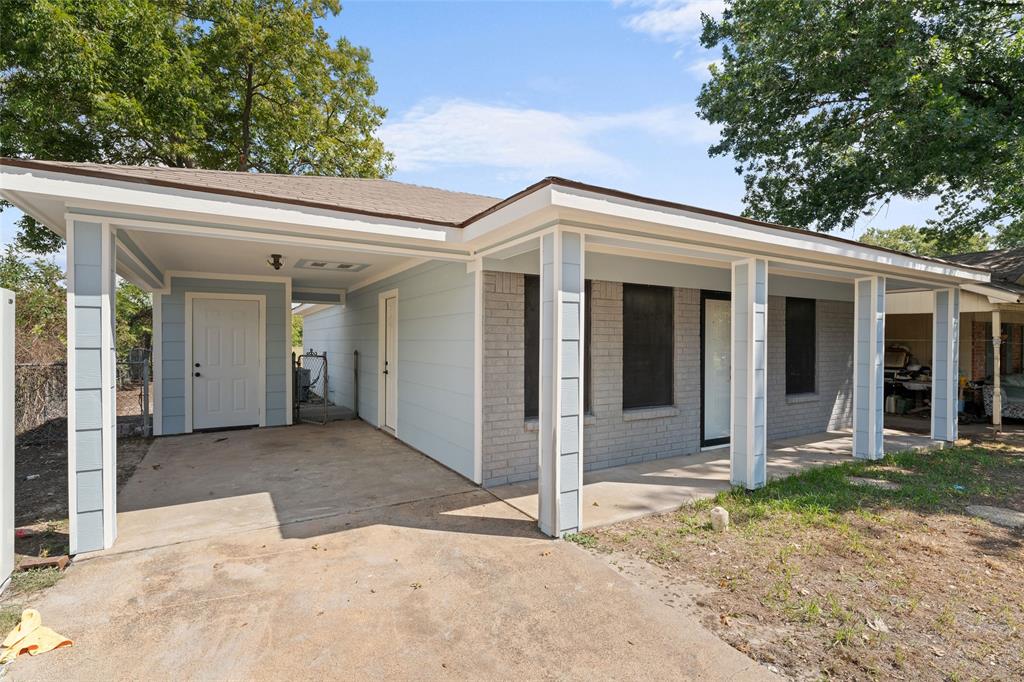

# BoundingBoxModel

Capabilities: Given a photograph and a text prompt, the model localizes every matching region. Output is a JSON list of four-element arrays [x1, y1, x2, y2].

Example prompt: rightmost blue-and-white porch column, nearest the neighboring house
[[932, 289, 962, 441]]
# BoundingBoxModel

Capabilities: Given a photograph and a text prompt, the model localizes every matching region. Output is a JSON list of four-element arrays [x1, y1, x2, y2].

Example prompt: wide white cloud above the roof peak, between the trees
[[380, 99, 717, 175]]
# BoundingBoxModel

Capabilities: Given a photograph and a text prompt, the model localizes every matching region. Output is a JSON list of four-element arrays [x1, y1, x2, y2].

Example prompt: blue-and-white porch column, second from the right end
[[853, 278, 886, 460]]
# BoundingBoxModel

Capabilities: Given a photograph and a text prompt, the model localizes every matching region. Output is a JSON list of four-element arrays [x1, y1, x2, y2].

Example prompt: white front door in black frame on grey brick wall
[[700, 292, 732, 446]]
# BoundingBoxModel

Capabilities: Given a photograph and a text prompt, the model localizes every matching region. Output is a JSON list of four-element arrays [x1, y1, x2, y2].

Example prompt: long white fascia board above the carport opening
[[0, 167, 462, 245]]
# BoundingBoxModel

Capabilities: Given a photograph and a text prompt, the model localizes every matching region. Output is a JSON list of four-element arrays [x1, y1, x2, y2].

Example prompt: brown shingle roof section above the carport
[[2, 159, 499, 226]]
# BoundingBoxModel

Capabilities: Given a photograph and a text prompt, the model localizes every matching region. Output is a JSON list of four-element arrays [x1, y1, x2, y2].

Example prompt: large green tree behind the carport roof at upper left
[[0, 0, 393, 253]]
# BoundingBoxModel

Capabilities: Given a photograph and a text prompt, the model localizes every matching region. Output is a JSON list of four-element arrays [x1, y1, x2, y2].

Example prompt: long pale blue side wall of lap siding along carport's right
[[303, 263, 474, 477]]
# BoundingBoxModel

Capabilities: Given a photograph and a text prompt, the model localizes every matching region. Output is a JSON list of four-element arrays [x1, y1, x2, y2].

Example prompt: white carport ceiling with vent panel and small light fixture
[[124, 230, 410, 289]]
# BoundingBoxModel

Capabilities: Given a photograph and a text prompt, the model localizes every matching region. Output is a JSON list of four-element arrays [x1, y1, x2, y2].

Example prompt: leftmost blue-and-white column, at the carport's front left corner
[[68, 220, 117, 554]]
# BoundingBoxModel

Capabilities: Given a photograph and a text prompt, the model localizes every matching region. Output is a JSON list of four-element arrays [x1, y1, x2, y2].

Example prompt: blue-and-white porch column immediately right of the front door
[[729, 258, 768, 491]]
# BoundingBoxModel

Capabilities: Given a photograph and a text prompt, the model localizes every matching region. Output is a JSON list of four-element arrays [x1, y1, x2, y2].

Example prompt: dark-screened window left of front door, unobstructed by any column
[[623, 284, 674, 410]]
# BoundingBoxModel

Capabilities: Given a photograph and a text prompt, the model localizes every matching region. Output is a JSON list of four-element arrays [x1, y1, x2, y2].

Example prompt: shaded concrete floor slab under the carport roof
[[104, 421, 536, 554]]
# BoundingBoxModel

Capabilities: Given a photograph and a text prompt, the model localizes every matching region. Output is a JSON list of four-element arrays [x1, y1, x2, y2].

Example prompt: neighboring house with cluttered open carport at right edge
[[886, 249, 1024, 424]]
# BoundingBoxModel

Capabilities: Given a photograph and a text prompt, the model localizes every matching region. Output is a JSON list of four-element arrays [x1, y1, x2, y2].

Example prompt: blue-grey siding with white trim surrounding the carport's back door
[[158, 276, 291, 435]]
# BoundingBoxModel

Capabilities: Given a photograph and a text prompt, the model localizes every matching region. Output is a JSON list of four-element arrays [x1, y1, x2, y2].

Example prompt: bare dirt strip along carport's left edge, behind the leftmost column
[[14, 438, 153, 561]]
